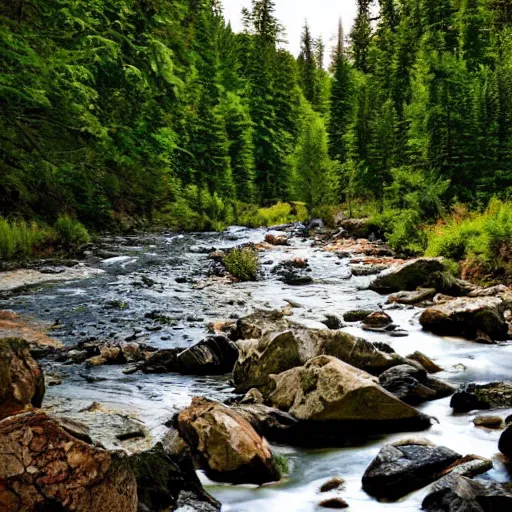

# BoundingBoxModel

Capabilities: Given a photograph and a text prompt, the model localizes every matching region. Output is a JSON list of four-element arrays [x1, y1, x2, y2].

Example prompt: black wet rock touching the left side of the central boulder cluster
[[177, 335, 238, 375]]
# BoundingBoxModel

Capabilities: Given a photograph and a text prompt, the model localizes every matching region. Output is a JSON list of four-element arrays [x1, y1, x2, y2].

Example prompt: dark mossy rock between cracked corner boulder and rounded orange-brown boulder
[[130, 443, 220, 512]]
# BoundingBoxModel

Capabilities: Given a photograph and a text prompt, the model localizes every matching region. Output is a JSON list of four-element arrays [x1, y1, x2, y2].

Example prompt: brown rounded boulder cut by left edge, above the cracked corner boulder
[[0, 338, 45, 419]]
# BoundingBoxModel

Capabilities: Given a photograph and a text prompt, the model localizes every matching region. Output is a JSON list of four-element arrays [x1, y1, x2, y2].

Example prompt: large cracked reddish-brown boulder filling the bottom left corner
[[0, 411, 137, 512]]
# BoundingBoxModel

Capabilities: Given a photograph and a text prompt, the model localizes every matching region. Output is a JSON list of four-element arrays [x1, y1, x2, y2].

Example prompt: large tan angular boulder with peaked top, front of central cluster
[[264, 356, 430, 431]]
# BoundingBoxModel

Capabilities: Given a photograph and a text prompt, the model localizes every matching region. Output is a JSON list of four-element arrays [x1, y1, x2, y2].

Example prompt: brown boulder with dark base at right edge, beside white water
[[420, 297, 509, 340]]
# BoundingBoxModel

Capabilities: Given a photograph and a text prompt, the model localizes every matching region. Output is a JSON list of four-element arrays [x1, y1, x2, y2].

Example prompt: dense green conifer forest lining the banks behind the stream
[[0, 0, 512, 274]]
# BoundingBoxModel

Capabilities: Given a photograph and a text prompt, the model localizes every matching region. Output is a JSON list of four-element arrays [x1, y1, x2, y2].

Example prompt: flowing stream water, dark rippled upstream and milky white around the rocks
[[0, 228, 512, 512]]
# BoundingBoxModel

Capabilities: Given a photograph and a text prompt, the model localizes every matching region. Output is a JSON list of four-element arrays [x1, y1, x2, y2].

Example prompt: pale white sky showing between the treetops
[[222, 0, 356, 55]]
